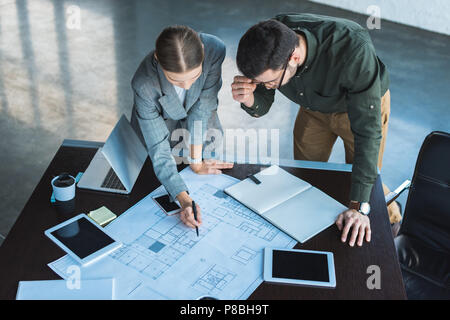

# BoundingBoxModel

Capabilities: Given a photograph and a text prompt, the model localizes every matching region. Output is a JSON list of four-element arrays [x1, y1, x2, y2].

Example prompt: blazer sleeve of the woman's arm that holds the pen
[[133, 88, 188, 200]]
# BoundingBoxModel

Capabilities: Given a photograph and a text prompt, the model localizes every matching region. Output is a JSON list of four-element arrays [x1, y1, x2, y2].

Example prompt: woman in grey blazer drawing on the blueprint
[[131, 26, 233, 228]]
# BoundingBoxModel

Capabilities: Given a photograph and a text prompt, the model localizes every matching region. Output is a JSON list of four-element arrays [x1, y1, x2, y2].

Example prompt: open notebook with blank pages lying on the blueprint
[[224, 165, 347, 243]]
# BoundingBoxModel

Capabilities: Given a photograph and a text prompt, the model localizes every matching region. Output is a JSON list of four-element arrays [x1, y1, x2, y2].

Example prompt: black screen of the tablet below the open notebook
[[272, 250, 330, 282]]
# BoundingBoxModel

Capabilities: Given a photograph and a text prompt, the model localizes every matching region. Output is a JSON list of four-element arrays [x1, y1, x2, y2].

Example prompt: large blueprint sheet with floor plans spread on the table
[[49, 167, 297, 299]]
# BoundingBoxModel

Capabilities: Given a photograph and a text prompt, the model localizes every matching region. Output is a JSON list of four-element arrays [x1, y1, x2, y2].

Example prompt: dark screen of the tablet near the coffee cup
[[51, 217, 115, 259]]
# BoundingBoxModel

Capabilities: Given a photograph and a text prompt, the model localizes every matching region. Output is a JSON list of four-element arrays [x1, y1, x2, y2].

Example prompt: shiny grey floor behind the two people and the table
[[0, 0, 450, 244]]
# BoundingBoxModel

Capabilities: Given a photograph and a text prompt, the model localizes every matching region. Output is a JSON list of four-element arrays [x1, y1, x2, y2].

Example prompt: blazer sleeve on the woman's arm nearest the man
[[187, 40, 226, 145]]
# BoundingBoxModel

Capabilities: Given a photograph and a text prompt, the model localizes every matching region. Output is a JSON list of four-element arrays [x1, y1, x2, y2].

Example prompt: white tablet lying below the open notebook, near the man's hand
[[264, 248, 336, 288]]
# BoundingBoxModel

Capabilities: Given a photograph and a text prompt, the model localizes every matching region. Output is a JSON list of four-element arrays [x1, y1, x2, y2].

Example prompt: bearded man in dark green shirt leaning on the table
[[231, 14, 400, 246]]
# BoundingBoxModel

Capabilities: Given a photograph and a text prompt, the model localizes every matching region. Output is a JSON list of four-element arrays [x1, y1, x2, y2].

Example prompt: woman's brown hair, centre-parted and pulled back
[[155, 26, 204, 73]]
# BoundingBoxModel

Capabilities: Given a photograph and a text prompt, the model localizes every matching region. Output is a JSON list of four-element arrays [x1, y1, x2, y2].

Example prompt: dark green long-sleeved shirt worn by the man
[[241, 14, 389, 202]]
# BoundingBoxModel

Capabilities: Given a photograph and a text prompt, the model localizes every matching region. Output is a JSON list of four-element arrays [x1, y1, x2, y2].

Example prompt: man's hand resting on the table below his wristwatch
[[336, 209, 371, 247]]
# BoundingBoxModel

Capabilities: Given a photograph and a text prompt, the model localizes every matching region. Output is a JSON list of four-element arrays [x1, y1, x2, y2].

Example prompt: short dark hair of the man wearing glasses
[[236, 20, 299, 79]]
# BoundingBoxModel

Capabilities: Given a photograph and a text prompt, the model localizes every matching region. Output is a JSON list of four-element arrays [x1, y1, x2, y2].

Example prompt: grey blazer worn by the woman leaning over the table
[[131, 33, 226, 199]]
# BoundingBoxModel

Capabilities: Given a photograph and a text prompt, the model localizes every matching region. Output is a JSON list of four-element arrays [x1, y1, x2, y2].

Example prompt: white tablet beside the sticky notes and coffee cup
[[45, 214, 122, 266]]
